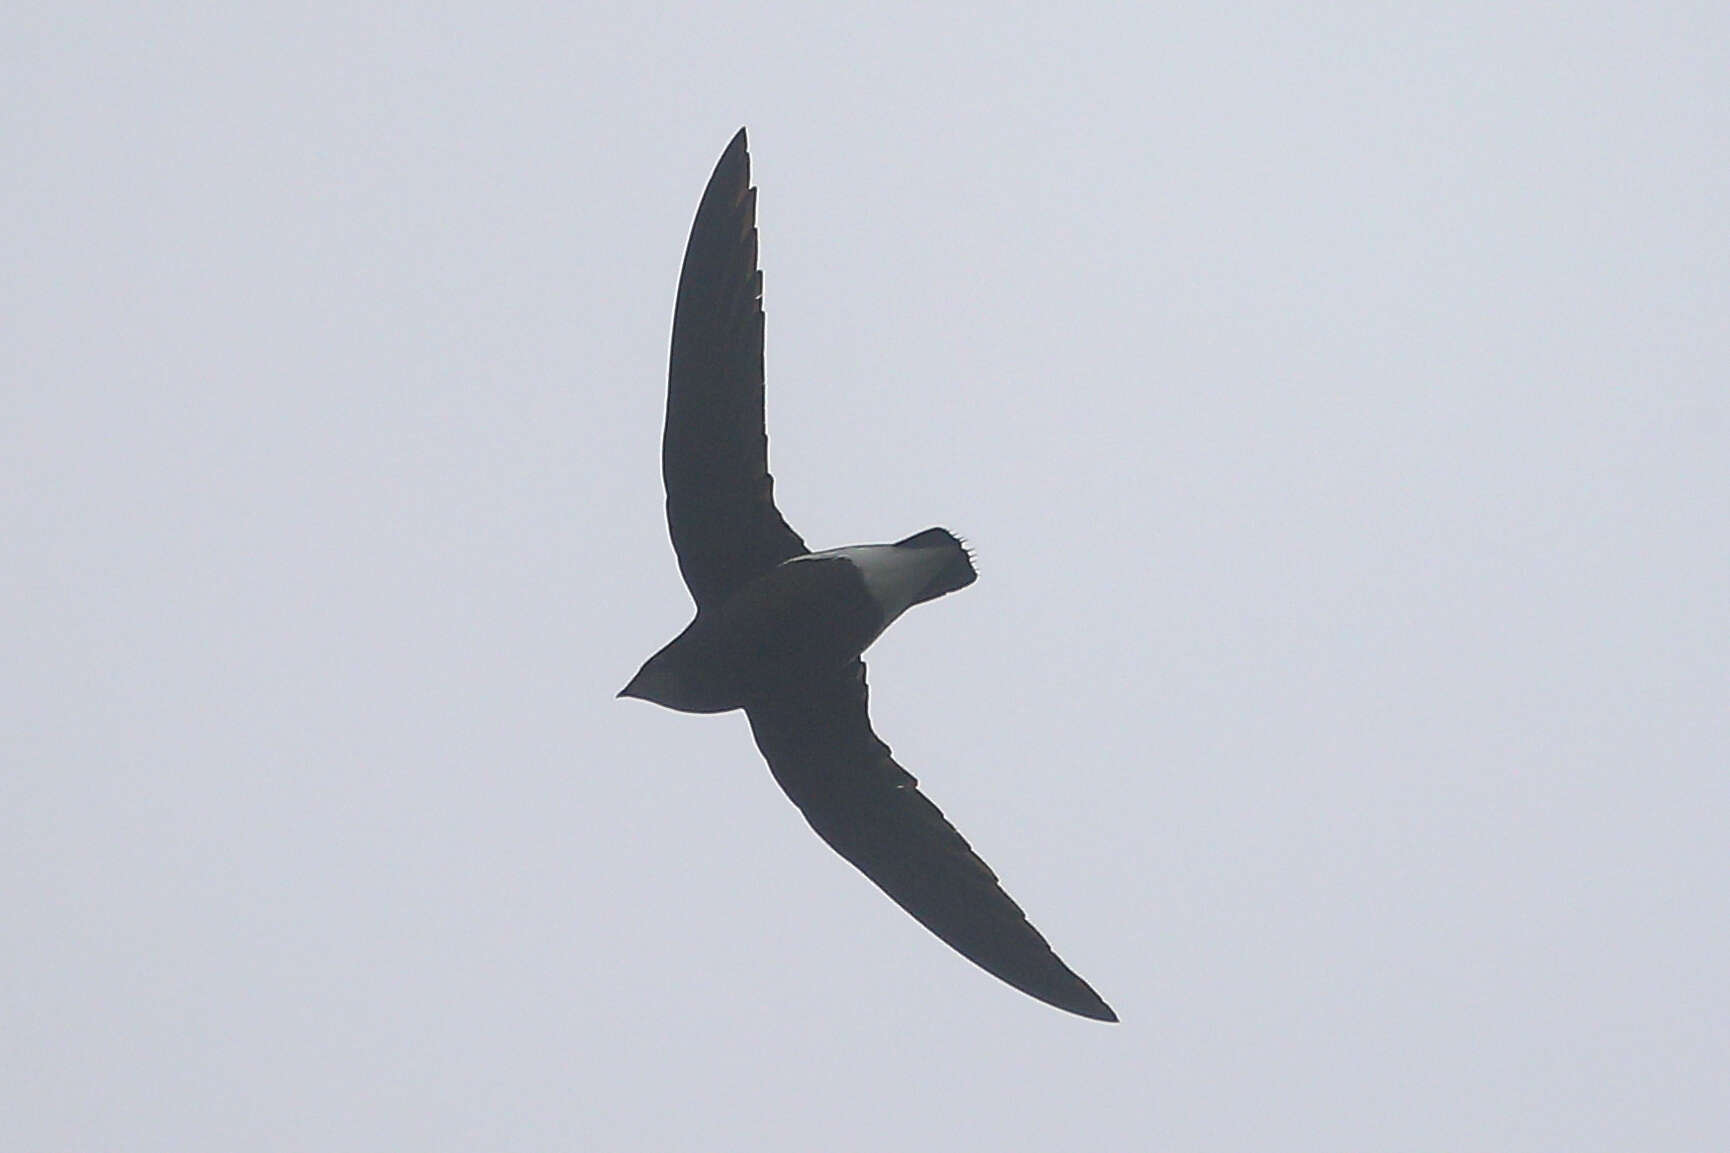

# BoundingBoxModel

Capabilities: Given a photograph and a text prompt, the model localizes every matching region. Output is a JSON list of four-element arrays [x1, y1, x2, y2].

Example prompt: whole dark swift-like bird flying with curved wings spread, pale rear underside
[[619, 128, 1118, 1021]]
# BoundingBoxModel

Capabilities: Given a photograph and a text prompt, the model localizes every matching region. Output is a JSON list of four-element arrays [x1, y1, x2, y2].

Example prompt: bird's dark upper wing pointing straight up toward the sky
[[661, 128, 806, 611]]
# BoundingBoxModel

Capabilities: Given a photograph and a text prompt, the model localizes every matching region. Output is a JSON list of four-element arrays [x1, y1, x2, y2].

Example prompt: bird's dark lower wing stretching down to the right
[[746, 650, 1118, 1021]]
